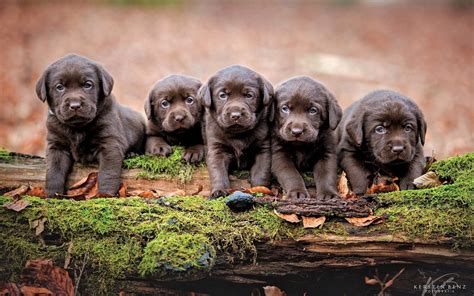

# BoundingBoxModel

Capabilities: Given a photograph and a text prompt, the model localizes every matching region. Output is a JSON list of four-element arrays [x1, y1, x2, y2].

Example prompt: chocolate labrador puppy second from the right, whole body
[[272, 76, 342, 199]]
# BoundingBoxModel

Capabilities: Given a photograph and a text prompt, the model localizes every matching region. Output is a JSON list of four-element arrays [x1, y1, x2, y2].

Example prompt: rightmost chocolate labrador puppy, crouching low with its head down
[[337, 90, 426, 195]]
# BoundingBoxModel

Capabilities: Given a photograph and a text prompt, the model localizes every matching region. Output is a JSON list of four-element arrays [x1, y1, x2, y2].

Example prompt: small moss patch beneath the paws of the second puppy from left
[[124, 146, 197, 182]]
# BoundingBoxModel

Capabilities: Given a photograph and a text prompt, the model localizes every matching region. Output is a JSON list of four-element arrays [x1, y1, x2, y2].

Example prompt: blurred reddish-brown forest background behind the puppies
[[0, 0, 474, 158]]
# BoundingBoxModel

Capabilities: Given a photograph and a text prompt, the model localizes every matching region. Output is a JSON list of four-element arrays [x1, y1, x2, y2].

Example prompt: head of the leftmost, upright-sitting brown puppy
[[36, 54, 114, 127]]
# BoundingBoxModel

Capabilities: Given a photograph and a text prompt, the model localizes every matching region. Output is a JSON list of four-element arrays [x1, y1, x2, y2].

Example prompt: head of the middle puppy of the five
[[199, 65, 273, 133]]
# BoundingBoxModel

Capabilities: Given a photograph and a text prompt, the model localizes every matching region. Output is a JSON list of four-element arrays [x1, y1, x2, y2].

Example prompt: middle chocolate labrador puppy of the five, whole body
[[199, 65, 273, 198]]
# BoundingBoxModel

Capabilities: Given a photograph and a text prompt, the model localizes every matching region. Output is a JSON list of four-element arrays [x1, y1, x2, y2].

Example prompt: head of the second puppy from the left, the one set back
[[145, 75, 202, 132]]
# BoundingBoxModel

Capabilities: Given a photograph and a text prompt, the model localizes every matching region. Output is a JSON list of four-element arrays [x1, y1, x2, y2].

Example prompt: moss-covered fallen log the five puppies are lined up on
[[0, 153, 474, 295]]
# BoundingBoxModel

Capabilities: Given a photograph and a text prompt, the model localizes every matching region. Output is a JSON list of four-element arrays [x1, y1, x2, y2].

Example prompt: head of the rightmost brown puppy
[[346, 91, 426, 164]]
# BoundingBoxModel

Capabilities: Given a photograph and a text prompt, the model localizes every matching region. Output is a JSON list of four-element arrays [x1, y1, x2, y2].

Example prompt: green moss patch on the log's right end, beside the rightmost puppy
[[376, 153, 474, 247]]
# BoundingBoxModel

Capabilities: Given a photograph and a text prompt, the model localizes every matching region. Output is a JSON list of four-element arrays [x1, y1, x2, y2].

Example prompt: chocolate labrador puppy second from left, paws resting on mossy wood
[[145, 75, 204, 163]]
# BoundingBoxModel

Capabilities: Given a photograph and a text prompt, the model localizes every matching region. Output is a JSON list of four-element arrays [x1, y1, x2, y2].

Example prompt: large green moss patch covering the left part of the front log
[[0, 196, 304, 294]]
